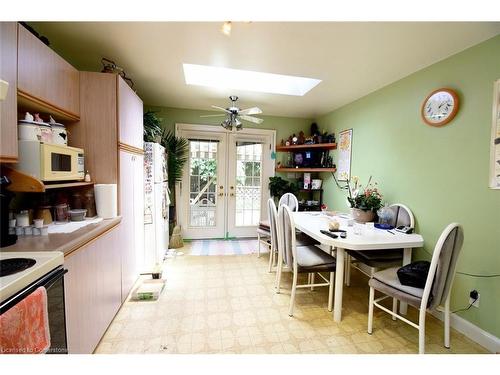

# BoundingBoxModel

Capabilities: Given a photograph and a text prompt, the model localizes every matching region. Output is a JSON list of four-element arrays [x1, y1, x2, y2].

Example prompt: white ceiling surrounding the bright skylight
[[31, 22, 500, 118]]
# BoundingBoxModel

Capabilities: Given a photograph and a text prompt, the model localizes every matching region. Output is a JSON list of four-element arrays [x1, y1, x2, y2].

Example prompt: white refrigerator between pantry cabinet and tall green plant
[[144, 142, 170, 272]]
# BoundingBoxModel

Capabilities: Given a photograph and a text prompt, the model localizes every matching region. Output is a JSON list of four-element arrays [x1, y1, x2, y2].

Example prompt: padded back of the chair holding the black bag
[[422, 223, 464, 309]]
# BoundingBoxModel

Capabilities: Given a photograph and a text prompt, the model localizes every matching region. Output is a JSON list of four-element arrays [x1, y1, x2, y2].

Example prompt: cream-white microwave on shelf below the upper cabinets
[[16, 140, 85, 181]]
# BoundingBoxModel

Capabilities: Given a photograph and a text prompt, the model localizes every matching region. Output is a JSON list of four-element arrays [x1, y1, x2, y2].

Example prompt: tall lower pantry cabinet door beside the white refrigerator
[[120, 151, 144, 301]]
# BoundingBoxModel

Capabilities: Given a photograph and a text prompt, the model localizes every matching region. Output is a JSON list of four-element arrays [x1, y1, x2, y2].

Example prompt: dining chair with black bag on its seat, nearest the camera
[[368, 223, 464, 354]]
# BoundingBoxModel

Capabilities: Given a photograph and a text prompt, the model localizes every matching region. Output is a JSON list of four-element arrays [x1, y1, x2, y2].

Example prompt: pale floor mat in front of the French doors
[[185, 239, 265, 255]]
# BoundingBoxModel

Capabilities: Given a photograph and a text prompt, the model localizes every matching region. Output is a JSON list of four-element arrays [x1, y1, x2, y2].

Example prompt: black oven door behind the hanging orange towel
[[0, 266, 68, 354]]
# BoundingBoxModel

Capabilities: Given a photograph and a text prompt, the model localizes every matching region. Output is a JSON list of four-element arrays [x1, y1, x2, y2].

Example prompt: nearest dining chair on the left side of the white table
[[276, 205, 336, 316]]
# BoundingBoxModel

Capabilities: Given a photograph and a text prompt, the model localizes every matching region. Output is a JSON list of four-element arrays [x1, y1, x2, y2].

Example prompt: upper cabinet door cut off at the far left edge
[[0, 22, 17, 163]]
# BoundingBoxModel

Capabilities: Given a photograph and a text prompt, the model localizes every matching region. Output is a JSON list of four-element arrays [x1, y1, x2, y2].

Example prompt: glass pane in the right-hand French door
[[236, 142, 262, 227]]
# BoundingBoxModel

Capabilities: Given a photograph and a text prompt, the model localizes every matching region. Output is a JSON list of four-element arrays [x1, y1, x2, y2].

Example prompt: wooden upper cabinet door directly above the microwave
[[17, 25, 80, 117]]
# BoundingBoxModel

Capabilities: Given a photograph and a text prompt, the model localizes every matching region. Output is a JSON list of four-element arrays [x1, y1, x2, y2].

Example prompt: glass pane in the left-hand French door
[[189, 140, 218, 227]]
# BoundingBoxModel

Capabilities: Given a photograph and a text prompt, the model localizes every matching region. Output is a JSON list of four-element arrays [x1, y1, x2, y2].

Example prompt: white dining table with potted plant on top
[[293, 212, 424, 322]]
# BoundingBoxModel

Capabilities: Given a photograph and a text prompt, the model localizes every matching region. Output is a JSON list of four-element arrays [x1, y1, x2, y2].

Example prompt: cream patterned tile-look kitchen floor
[[96, 241, 486, 354]]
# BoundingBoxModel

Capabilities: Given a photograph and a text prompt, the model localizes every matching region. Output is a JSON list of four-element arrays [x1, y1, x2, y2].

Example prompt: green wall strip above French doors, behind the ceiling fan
[[145, 105, 312, 143]]
